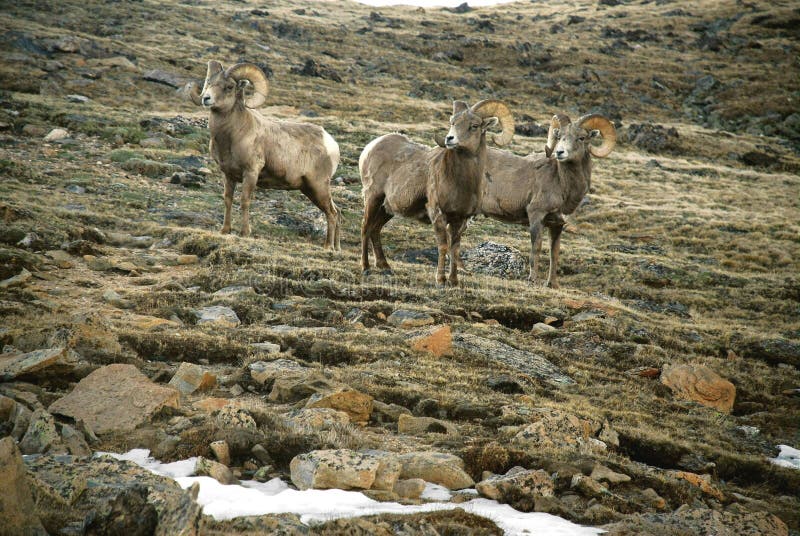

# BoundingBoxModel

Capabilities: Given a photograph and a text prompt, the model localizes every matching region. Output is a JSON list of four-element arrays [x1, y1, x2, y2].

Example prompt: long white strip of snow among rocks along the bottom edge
[[108, 449, 604, 536]]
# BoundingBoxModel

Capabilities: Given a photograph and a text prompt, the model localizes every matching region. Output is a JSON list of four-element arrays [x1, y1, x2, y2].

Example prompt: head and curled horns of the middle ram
[[434, 99, 514, 153]]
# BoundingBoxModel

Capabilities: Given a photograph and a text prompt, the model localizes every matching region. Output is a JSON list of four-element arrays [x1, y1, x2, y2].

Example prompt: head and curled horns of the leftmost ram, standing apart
[[192, 60, 269, 111]]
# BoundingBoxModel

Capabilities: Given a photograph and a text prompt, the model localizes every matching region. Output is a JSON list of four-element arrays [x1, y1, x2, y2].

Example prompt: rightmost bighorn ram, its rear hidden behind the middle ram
[[481, 114, 617, 288]]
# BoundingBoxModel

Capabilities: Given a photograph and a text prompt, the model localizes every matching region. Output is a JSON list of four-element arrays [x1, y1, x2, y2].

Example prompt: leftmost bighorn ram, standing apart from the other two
[[187, 61, 340, 249]]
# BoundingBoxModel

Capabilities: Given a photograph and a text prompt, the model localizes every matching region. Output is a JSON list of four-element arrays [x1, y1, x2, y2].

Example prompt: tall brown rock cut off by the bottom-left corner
[[0, 437, 47, 536]]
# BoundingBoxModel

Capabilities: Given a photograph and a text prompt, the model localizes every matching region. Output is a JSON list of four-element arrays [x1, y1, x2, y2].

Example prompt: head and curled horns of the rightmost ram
[[544, 114, 617, 162]]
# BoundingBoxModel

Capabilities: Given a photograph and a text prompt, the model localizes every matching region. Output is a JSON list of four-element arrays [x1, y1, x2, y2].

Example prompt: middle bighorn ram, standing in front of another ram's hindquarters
[[358, 100, 514, 286]]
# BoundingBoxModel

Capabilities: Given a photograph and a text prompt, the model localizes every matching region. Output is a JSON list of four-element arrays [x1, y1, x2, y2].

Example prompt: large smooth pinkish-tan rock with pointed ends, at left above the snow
[[48, 364, 179, 434]]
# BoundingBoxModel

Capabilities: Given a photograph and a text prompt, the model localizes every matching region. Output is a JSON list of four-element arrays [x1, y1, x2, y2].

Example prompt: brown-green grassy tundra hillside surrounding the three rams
[[0, 0, 800, 534]]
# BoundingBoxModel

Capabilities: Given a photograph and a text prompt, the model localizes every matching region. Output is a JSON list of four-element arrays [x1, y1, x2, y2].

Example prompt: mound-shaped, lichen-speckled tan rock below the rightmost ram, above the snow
[[513, 408, 606, 454]]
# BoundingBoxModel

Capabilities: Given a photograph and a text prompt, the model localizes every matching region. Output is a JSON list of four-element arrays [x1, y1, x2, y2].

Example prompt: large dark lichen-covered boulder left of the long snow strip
[[28, 455, 201, 536]]
